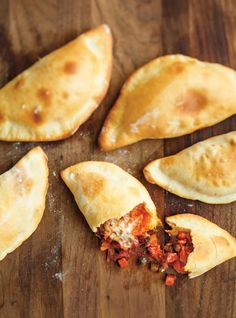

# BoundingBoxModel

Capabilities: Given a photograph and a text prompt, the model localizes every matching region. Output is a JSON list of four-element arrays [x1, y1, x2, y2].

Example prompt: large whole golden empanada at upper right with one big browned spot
[[99, 54, 236, 151]]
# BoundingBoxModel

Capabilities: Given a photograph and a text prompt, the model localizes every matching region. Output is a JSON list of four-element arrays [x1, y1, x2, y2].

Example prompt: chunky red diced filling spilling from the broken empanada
[[96, 204, 193, 286]]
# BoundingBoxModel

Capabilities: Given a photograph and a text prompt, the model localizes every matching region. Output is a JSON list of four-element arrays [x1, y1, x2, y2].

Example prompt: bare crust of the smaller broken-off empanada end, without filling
[[166, 214, 236, 278]]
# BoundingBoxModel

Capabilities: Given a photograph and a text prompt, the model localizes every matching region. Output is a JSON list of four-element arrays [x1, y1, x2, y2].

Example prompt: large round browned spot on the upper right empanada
[[175, 89, 207, 114]]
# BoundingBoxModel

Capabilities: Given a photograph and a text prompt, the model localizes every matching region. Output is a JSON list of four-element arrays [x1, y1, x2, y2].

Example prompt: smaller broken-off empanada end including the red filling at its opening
[[166, 214, 236, 278]]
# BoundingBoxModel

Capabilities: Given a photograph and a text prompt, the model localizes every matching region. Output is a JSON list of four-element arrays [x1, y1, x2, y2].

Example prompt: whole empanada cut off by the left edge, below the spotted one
[[0, 147, 48, 260]]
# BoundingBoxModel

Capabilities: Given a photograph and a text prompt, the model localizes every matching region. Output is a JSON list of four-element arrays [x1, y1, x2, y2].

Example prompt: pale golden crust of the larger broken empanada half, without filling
[[61, 161, 160, 232]]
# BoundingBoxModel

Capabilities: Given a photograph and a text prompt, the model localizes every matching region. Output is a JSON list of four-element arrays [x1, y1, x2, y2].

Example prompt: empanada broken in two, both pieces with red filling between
[[61, 161, 236, 285]]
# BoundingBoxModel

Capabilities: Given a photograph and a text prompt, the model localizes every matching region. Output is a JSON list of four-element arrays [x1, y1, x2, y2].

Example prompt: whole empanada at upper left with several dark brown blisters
[[0, 25, 112, 141]]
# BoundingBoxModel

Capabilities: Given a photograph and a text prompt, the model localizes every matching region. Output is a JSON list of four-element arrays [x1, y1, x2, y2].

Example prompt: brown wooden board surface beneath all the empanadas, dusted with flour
[[0, 0, 236, 318]]
